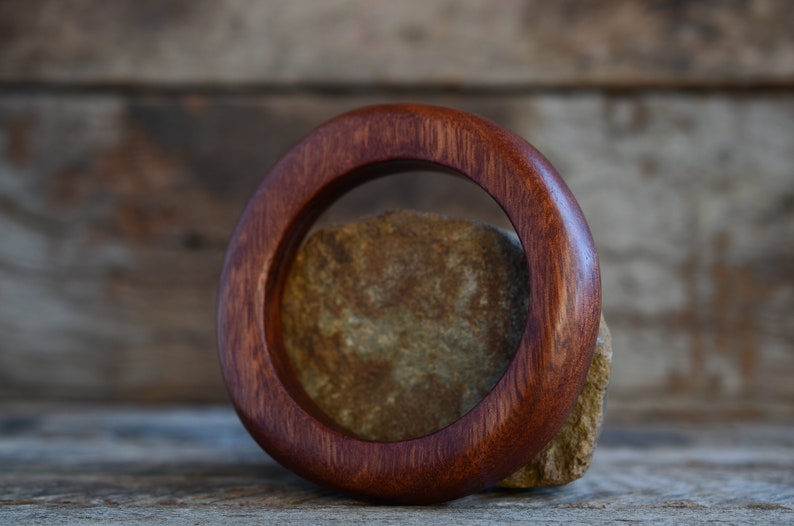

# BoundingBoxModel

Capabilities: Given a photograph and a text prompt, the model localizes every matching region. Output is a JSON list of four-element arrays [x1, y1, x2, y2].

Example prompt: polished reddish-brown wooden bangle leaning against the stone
[[213, 104, 601, 504]]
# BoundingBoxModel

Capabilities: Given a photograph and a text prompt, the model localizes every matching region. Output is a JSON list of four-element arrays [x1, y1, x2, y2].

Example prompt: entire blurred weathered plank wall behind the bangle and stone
[[0, 0, 794, 420]]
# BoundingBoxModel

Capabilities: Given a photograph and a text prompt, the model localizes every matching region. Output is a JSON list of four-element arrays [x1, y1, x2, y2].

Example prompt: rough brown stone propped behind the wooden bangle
[[283, 212, 612, 488]]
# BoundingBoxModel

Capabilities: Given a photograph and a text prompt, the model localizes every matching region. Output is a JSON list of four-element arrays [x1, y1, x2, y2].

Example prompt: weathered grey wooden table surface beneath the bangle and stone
[[0, 404, 794, 525]]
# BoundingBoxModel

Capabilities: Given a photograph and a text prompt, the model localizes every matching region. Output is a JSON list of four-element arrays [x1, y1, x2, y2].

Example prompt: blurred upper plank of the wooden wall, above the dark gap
[[0, 0, 794, 87]]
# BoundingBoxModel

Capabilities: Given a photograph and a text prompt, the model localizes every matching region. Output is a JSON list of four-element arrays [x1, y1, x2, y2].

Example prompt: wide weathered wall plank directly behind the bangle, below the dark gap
[[0, 93, 794, 417]]
